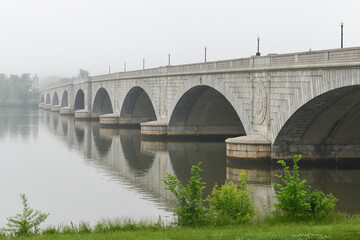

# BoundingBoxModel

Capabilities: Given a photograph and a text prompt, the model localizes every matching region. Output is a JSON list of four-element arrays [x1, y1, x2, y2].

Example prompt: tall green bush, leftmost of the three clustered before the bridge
[[163, 163, 211, 226]]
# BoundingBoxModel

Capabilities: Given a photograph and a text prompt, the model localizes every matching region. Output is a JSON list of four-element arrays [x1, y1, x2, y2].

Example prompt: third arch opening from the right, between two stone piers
[[120, 87, 156, 127]]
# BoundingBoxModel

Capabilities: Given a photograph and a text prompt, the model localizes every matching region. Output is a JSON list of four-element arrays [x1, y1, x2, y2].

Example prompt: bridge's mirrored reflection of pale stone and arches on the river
[[40, 112, 360, 213]]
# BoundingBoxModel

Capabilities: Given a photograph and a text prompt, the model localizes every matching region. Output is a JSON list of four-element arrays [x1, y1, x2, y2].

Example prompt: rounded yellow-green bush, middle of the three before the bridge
[[208, 173, 255, 223]]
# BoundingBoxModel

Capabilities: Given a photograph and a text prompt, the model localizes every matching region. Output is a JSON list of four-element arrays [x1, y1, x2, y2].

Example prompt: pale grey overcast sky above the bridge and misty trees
[[0, 0, 360, 79]]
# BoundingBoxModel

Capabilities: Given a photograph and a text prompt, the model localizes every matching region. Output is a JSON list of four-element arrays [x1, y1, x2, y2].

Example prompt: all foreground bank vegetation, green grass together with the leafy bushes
[[0, 155, 360, 240]]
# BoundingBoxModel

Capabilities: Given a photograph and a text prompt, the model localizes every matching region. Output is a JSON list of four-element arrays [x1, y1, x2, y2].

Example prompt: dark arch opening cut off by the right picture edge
[[273, 86, 360, 159]]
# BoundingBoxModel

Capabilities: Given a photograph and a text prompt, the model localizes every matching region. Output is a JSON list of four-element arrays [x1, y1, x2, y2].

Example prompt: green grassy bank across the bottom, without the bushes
[[4, 216, 360, 240]]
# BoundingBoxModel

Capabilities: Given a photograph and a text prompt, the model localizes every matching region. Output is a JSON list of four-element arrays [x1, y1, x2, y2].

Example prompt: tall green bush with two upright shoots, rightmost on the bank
[[273, 155, 337, 220]]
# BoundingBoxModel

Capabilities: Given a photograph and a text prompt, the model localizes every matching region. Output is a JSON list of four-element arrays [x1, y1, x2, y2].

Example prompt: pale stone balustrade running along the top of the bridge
[[43, 47, 360, 88]]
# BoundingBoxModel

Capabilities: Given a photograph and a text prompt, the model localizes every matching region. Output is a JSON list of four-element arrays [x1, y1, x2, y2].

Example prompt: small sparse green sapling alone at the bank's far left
[[6, 194, 49, 236]]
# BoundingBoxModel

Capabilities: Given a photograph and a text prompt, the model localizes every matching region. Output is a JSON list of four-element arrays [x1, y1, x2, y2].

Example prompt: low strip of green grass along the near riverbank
[[0, 213, 360, 240]]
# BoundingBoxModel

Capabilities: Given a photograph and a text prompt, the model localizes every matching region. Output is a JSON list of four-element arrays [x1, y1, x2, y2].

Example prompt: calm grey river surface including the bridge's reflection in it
[[0, 109, 360, 227]]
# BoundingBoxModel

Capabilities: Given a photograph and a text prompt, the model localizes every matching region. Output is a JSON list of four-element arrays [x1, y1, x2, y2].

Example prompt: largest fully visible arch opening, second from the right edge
[[168, 86, 246, 140]]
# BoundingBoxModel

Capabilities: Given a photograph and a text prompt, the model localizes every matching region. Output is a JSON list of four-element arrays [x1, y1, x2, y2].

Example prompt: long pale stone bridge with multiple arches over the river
[[39, 47, 360, 160]]
